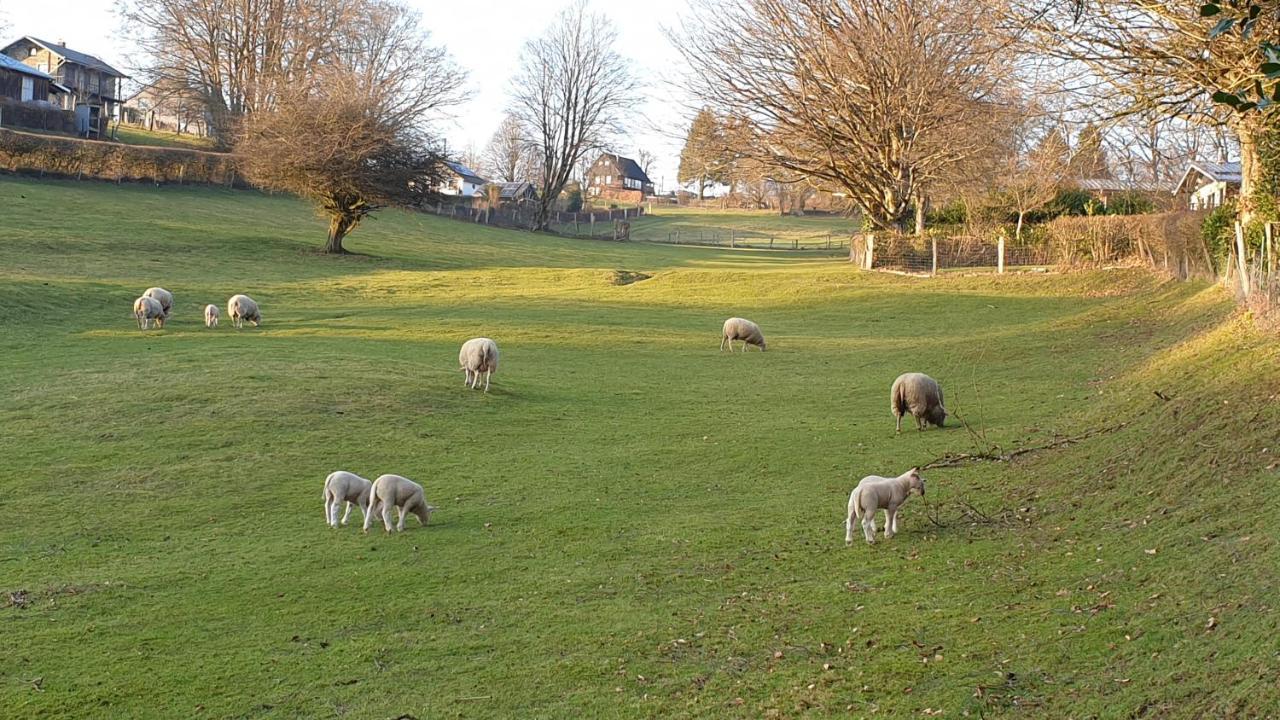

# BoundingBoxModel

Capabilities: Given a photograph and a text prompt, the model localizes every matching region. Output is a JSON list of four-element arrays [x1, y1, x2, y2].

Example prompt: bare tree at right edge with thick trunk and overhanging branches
[[1018, 0, 1280, 222]]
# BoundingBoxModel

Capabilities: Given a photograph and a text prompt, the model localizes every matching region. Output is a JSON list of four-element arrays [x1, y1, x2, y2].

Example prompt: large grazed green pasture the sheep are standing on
[[0, 178, 1280, 717]]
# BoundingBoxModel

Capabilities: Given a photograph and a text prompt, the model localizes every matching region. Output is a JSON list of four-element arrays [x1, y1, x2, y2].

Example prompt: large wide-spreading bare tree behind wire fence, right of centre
[[673, 0, 1010, 228]]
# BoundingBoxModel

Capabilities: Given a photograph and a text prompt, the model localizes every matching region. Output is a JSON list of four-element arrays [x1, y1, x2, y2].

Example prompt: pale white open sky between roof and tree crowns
[[0, 0, 691, 190]]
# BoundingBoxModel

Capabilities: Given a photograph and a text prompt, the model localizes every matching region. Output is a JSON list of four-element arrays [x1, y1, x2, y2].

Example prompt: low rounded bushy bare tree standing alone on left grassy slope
[[236, 4, 465, 254]]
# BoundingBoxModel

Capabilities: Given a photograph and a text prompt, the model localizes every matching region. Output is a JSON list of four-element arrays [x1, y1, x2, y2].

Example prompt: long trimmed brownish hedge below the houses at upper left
[[0, 129, 244, 186]]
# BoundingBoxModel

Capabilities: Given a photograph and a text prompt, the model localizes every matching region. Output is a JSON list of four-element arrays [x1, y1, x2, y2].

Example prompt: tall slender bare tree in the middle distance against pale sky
[[512, 0, 632, 229]]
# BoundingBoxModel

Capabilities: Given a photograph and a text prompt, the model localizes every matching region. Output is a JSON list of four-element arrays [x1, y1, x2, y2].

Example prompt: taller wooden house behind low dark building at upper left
[[0, 36, 128, 137]]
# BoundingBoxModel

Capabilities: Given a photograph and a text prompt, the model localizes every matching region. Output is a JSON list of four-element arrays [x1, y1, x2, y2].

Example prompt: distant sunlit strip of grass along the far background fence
[[631, 205, 859, 252]]
